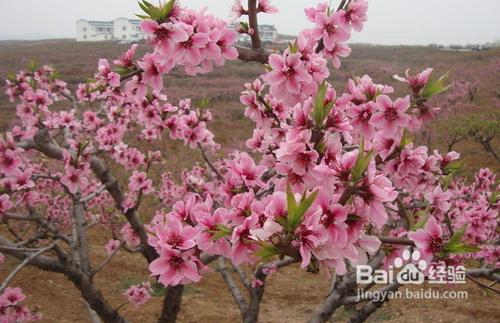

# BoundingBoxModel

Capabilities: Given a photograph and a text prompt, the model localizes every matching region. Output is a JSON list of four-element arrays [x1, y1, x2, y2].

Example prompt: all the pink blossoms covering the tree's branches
[[0, 0, 499, 298]]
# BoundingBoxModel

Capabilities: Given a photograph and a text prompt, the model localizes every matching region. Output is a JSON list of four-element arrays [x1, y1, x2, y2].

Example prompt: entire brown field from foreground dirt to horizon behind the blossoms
[[0, 41, 500, 323]]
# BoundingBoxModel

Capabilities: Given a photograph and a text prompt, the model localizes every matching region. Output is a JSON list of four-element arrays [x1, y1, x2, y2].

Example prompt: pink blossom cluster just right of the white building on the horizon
[[139, 6, 238, 86]]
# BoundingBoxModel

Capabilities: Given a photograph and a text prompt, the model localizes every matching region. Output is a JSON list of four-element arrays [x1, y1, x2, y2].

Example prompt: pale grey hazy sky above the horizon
[[0, 0, 500, 44]]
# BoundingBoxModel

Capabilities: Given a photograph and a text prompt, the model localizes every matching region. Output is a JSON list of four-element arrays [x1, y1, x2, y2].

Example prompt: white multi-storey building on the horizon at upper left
[[76, 18, 146, 42]]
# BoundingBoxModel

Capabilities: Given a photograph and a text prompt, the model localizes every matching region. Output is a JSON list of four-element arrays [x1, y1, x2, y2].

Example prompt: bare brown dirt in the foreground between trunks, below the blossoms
[[0, 230, 500, 323]]
